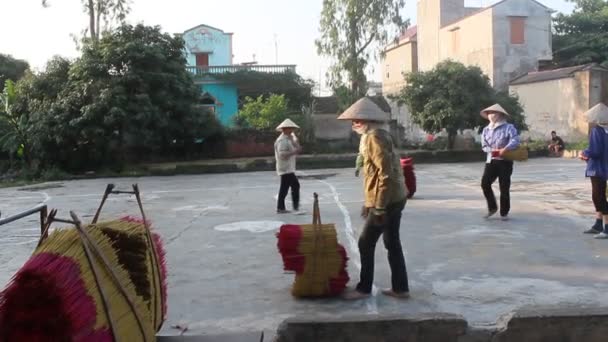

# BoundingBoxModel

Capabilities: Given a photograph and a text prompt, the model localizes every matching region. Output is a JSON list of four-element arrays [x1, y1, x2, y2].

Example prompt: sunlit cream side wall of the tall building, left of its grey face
[[439, 9, 495, 81]]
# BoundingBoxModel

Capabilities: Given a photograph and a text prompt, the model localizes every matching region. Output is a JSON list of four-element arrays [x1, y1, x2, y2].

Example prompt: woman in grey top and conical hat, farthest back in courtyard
[[274, 119, 302, 214]]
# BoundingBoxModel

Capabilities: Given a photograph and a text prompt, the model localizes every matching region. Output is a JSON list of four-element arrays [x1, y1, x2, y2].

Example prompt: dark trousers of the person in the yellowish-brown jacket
[[357, 201, 409, 293]]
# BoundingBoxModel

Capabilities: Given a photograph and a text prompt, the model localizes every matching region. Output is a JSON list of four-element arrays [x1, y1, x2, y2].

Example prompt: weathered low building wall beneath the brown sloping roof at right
[[509, 71, 590, 142]]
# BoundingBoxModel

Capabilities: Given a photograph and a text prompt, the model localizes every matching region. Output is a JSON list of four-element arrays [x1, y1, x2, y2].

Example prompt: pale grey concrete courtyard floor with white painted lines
[[0, 158, 608, 335]]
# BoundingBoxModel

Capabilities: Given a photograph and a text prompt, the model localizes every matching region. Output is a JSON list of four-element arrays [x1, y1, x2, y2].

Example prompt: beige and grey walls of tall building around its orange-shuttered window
[[417, 0, 552, 90]]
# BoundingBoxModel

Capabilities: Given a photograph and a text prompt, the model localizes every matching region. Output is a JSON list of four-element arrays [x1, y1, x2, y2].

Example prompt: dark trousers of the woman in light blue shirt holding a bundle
[[481, 159, 513, 216]]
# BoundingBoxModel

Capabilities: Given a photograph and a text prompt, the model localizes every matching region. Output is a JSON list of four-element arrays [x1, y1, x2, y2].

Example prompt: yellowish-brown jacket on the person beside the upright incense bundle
[[363, 129, 407, 210]]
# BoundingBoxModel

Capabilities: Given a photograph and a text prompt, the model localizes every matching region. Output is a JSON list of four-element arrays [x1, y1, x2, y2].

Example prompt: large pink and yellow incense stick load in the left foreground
[[0, 188, 166, 342]]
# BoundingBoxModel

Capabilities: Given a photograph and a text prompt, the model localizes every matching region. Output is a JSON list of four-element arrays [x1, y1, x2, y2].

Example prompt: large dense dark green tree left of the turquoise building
[[21, 25, 220, 171]]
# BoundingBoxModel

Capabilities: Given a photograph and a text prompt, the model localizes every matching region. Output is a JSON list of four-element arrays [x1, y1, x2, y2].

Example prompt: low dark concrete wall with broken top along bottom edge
[[276, 307, 608, 342]]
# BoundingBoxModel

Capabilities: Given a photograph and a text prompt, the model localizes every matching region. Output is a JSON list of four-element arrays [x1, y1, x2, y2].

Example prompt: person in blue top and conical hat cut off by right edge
[[579, 103, 608, 239]]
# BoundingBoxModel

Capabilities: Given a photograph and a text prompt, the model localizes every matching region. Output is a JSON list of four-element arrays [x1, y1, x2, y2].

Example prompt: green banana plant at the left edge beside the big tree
[[0, 80, 29, 162]]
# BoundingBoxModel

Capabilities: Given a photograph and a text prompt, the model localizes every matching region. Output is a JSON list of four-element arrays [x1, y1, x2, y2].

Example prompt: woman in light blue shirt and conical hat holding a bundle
[[480, 104, 519, 220]]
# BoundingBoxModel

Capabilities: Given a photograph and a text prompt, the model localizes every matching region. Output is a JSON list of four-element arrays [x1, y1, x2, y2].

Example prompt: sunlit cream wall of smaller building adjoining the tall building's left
[[382, 41, 418, 95]]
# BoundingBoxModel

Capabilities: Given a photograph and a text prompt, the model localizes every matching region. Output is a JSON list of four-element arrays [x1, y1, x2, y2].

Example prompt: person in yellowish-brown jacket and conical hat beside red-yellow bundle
[[338, 97, 409, 299]]
